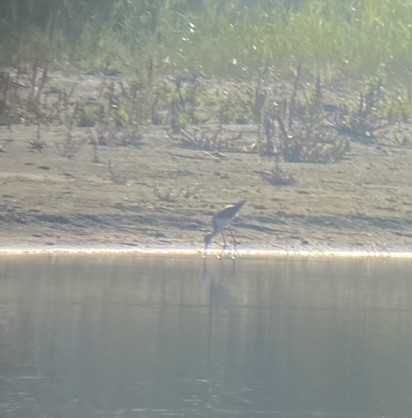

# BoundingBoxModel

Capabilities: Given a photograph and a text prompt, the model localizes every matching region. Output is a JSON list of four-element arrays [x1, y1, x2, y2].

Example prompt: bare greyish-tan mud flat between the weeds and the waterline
[[0, 72, 412, 251]]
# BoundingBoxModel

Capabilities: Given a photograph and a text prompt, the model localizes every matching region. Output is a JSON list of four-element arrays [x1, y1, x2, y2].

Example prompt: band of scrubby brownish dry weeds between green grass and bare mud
[[0, 58, 411, 191]]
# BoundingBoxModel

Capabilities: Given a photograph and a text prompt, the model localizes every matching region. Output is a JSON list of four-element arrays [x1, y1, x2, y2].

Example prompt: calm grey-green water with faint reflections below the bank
[[0, 256, 412, 418]]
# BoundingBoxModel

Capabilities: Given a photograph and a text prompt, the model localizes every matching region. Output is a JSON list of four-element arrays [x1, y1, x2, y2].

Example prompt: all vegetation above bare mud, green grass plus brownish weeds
[[0, 0, 412, 163]]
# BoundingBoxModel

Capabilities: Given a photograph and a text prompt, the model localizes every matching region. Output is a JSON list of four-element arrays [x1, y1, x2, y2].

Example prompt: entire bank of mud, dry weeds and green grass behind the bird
[[0, 0, 412, 251]]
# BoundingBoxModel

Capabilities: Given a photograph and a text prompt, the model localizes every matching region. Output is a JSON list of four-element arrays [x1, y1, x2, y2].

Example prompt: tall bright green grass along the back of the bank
[[0, 0, 412, 84]]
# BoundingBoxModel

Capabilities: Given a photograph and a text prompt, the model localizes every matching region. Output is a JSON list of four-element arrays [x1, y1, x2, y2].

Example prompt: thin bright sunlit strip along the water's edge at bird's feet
[[0, 246, 412, 259]]
